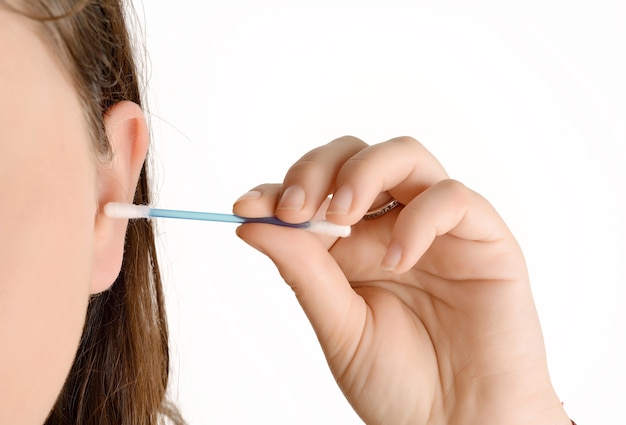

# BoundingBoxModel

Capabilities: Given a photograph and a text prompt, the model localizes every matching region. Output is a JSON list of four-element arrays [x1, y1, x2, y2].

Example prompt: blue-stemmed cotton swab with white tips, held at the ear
[[104, 202, 350, 238]]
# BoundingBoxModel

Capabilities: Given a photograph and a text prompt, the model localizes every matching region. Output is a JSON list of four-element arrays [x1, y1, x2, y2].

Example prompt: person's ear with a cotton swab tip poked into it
[[90, 101, 149, 294]]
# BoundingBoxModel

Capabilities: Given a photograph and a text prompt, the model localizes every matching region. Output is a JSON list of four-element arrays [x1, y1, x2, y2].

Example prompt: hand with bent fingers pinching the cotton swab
[[234, 137, 570, 425]]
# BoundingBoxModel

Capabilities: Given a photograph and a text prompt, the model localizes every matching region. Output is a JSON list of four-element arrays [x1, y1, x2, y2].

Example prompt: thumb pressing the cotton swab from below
[[237, 224, 366, 360]]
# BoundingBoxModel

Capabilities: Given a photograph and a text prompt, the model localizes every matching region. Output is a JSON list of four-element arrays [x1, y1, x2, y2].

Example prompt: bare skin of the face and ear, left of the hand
[[0, 8, 148, 424]]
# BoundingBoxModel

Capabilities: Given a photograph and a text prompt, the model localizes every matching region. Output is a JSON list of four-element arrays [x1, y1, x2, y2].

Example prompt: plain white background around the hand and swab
[[135, 0, 626, 424]]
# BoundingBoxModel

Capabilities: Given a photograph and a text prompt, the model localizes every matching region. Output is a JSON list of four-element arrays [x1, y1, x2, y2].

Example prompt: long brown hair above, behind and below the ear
[[0, 0, 183, 425]]
